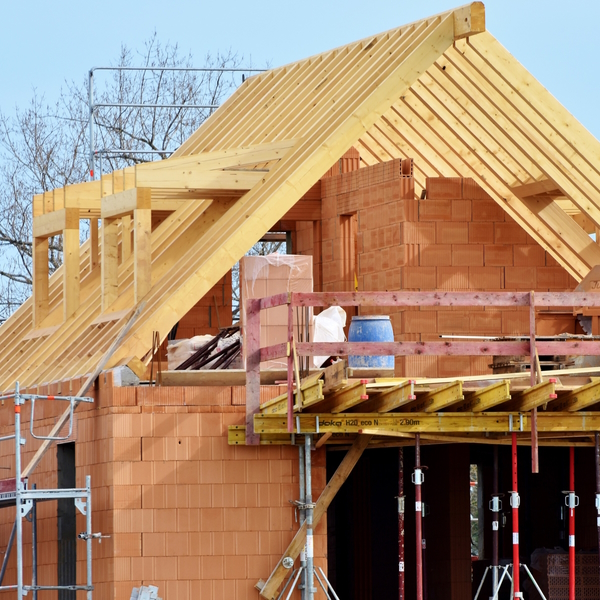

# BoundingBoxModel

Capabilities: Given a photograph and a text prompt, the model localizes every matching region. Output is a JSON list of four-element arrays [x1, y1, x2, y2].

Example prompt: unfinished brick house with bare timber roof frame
[[0, 2, 600, 600]]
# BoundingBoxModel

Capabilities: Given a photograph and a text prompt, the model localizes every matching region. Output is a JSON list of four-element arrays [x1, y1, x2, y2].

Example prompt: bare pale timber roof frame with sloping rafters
[[0, 3, 600, 388]]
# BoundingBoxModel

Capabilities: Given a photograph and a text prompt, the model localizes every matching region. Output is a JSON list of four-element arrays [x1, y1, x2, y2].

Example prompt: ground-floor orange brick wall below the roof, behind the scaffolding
[[0, 382, 327, 600]]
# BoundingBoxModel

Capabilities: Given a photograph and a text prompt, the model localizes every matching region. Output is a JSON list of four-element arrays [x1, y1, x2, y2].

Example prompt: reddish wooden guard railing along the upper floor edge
[[244, 292, 600, 454]]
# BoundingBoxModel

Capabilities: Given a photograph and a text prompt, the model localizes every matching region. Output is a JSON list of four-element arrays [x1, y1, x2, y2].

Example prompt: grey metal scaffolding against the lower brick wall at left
[[0, 382, 96, 600]]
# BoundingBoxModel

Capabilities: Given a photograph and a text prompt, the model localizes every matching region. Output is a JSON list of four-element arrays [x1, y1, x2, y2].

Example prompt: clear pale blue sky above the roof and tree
[[0, 0, 600, 138]]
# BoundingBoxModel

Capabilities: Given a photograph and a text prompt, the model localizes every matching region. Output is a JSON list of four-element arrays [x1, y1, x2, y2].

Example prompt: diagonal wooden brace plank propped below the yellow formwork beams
[[260, 435, 371, 600]]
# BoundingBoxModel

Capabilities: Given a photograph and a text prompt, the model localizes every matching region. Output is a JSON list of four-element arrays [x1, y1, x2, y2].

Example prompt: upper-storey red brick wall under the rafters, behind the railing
[[296, 160, 576, 377]]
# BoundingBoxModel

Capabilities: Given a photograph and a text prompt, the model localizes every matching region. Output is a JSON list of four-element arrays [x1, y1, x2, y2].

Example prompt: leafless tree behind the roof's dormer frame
[[0, 33, 242, 321]]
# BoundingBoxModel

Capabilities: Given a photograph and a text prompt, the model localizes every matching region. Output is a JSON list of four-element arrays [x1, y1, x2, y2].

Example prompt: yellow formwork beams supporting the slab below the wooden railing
[[229, 365, 600, 446]]
